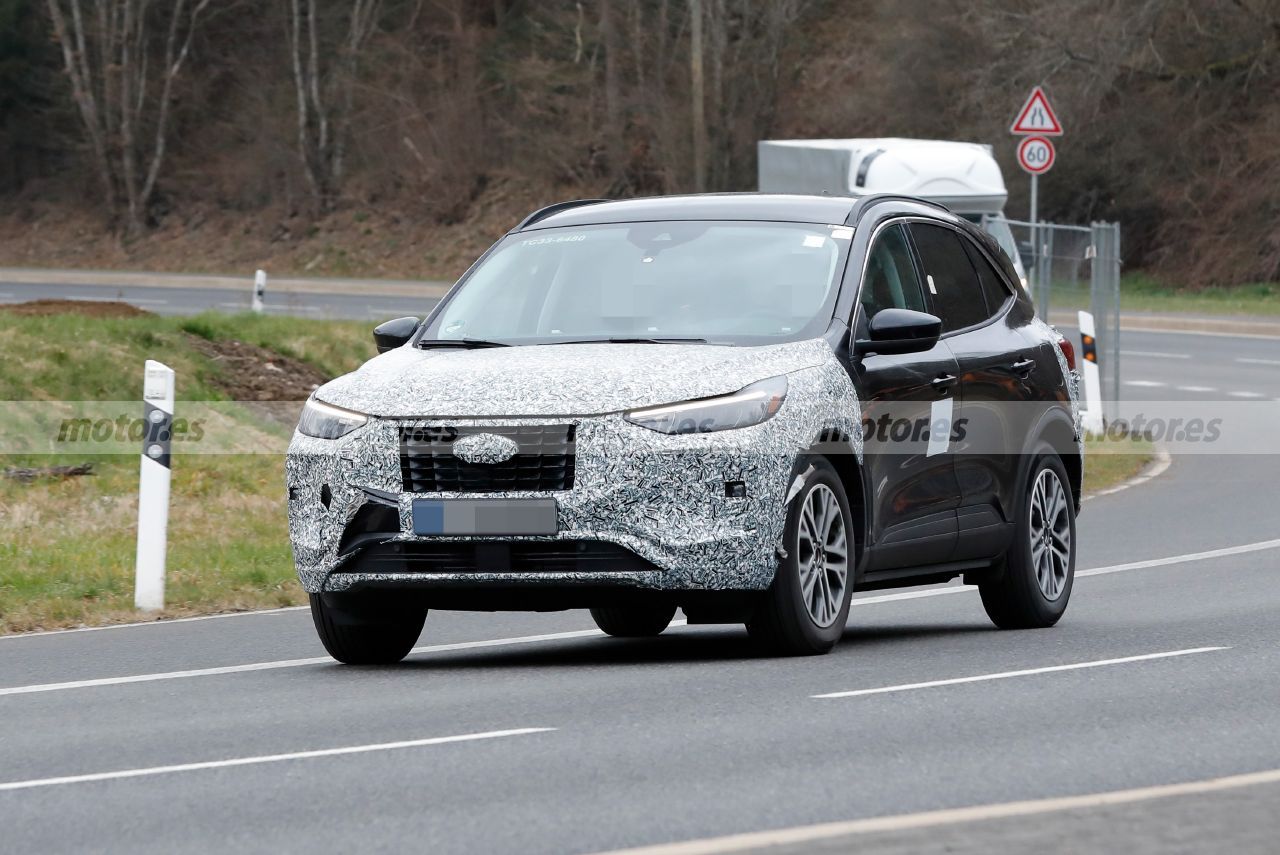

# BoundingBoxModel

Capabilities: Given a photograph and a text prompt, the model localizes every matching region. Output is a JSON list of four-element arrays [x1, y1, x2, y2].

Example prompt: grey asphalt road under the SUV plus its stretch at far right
[[0, 325, 1280, 852]]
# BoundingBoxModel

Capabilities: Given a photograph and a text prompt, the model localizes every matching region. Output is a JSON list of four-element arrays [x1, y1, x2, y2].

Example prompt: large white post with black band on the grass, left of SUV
[[133, 360, 174, 612]]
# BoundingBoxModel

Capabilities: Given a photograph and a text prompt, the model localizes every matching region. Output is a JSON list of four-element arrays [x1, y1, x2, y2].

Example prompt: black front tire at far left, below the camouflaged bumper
[[311, 594, 426, 666]]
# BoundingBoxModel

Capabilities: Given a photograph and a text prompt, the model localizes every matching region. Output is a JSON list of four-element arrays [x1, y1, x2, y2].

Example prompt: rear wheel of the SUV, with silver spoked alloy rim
[[978, 449, 1075, 630]]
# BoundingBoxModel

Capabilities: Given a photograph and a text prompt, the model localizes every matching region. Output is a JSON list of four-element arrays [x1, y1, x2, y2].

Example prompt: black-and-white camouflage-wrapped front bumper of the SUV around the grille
[[285, 364, 860, 593]]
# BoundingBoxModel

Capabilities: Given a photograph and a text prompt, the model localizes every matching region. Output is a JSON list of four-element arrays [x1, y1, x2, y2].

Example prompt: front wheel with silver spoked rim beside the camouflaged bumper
[[746, 457, 858, 655]]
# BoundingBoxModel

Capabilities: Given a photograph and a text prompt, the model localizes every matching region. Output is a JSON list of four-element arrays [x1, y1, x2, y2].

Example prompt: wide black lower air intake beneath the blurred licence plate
[[334, 540, 657, 573]]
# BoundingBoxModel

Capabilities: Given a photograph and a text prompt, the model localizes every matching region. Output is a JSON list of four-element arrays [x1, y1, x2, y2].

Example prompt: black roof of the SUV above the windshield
[[515, 193, 859, 232]]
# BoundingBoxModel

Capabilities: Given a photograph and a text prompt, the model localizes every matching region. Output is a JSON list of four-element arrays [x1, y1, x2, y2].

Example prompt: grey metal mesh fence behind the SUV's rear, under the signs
[[993, 219, 1120, 422]]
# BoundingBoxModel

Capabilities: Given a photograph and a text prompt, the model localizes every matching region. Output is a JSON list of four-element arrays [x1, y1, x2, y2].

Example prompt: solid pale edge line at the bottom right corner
[[596, 769, 1280, 855]]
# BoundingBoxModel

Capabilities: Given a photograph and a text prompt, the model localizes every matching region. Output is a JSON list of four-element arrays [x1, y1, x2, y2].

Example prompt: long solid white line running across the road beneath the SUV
[[10, 538, 1280, 696]]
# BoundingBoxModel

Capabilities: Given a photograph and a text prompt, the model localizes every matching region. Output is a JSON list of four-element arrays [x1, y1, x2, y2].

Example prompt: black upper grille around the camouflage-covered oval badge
[[401, 425, 573, 493]]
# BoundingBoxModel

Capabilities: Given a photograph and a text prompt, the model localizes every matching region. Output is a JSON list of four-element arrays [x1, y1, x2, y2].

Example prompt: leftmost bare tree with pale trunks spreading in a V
[[47, 0, 211, 233]]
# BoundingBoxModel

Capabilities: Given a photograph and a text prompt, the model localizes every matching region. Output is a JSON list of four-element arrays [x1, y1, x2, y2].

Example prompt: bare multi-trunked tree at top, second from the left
[[288, 0, 381, 211]]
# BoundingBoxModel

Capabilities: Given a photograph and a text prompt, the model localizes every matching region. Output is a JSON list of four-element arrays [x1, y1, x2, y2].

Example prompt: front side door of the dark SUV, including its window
[[851, 224, 960, 571]]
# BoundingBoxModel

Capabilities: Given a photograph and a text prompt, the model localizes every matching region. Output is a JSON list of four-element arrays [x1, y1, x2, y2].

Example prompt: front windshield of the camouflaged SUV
[[422, 221, 852, 344]]
